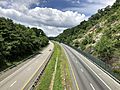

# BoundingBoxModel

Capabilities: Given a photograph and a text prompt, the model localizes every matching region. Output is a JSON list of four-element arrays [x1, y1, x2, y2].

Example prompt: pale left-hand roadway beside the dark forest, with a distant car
[[0, 42, 54, 90]]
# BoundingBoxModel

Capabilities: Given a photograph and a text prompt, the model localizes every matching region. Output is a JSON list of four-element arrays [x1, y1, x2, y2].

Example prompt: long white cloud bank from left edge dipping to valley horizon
[[0, 7, 86, 36]]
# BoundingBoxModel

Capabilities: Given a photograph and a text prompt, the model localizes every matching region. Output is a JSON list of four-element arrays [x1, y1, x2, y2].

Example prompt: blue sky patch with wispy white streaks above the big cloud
[[31, 0, 115, 16]]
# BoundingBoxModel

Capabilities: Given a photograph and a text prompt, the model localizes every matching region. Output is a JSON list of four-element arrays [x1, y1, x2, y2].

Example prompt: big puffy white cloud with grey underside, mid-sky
[[28, 7, 85, 27]]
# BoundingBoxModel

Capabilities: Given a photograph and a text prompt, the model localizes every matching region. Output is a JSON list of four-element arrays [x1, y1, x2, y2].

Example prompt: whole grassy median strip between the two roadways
[[36, 42, 71, 90]]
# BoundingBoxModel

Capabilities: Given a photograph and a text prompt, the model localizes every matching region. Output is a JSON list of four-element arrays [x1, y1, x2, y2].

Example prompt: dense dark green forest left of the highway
[[0, 17, 48, 70]]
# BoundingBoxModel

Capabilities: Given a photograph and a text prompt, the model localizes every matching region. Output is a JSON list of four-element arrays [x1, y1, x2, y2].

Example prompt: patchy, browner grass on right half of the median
[[53, 44, 72, 90]]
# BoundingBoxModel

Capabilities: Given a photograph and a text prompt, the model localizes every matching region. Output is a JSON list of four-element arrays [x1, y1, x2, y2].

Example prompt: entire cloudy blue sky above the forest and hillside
[[0, 0, 116, 37]]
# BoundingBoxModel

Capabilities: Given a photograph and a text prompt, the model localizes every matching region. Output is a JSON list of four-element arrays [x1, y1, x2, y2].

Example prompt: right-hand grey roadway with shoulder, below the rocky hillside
[[61, 44, 120, 90]]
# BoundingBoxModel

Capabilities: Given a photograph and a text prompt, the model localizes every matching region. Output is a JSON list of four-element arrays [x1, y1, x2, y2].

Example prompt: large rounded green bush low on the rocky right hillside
[[95, 36, 114, 61]]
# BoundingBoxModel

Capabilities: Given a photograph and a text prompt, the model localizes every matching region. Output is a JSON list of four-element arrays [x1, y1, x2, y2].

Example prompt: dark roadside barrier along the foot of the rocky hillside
[[66, 44, 120, 83]]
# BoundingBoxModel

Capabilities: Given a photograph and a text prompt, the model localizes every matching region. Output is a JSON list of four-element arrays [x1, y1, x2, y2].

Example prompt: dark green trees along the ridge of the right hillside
[[55, 3, 104, 44]]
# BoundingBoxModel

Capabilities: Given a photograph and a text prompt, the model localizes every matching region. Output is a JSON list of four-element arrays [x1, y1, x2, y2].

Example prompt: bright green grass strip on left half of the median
[[37, 44, 59, 90]]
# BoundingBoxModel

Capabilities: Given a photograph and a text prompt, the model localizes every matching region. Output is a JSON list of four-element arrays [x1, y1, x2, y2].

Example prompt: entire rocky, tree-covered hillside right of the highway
[[55, 0, 120, 73]]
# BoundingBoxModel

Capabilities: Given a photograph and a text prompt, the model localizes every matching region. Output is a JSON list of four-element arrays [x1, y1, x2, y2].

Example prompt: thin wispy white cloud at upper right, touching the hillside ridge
[[63, 0, 116, 16]]
